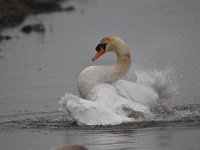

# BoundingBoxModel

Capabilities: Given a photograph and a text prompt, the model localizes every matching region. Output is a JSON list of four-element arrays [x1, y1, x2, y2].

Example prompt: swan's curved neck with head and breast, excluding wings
[[78, 36, 131, 100]]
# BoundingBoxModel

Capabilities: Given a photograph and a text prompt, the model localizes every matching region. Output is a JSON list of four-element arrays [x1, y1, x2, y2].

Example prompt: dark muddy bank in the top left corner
[[0, 0, 74, 31]]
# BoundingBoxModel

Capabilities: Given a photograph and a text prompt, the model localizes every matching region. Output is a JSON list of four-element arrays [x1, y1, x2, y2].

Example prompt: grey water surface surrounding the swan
[[0, 0, 200, 150]]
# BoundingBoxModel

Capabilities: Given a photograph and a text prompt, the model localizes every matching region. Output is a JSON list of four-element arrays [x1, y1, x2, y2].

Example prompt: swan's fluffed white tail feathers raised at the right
[[136, 70, 177, 101]]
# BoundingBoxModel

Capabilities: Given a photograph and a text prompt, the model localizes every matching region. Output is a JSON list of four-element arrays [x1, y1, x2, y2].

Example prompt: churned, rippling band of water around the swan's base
[[0, 104, 200, 132]]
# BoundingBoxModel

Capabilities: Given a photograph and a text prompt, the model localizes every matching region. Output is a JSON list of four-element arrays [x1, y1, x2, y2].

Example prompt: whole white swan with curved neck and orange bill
[[59, 36, 173, 125]]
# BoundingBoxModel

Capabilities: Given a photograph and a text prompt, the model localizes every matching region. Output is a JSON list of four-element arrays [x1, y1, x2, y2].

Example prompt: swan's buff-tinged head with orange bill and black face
[[92, 36, 127, 61]]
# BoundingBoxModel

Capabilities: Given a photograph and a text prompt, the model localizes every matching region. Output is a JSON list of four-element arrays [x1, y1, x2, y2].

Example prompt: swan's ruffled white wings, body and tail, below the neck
[[59, 71, 175, 125]]
